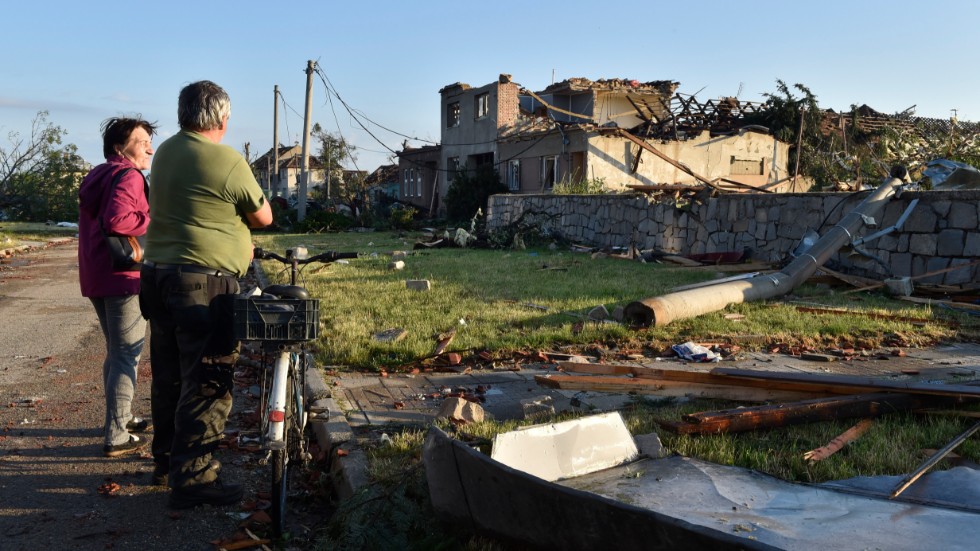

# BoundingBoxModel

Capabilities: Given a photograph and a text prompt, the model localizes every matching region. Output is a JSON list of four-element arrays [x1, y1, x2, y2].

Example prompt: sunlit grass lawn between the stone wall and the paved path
[[256, 232, 957, 370]]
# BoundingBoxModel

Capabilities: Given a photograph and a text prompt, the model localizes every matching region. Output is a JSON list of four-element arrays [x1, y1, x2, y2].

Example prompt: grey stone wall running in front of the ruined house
[[487, 190, 980, 285]]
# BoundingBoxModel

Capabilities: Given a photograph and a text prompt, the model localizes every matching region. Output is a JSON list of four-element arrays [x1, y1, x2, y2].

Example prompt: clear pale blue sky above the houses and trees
[[0, 0, 980, 172]]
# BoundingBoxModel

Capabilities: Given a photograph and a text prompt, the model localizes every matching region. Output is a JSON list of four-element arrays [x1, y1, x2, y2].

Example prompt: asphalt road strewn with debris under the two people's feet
[[0, 241, 322, 551]]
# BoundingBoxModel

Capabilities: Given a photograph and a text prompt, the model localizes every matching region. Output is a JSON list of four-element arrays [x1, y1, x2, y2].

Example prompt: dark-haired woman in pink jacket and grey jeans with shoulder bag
[[78, 116, 156, 457]]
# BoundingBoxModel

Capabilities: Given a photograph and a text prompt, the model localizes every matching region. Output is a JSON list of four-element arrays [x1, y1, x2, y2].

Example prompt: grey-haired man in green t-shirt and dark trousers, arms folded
[[140, 80, 272, 509]]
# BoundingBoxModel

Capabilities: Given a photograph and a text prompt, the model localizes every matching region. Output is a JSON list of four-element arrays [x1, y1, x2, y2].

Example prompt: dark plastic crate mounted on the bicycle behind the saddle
[[235, 295, 320, 341]]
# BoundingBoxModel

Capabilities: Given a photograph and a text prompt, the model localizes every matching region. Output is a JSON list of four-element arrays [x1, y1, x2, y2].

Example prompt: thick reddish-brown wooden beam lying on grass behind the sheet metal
[[682, 392, 952, 434]]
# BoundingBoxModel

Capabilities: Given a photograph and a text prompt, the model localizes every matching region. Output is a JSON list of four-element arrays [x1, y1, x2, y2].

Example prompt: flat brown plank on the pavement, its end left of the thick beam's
[[534, 375, 813, 402]]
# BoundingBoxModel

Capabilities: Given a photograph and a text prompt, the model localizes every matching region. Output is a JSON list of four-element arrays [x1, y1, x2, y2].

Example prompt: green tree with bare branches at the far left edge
[[0, 111, 85, 220]]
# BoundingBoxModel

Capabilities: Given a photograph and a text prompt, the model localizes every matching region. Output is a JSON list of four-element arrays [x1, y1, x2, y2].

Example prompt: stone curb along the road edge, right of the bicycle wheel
[[252, 259, 370, 500]]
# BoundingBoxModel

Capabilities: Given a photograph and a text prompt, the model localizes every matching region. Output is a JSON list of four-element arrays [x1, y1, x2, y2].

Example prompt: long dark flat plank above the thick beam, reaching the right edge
[[711, 367, 980, 400]]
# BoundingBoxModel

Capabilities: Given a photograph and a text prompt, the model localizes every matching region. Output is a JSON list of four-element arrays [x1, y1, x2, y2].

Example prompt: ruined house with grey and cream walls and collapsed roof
[[399, 74, 792, 212]]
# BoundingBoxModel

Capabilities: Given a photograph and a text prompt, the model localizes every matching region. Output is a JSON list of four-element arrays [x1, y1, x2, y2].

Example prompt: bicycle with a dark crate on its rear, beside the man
[[234, 248, 357, 536]]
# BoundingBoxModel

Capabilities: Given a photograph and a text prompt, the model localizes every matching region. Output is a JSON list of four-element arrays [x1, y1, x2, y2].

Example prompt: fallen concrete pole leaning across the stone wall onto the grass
[[623, 174, 904, 327]]
